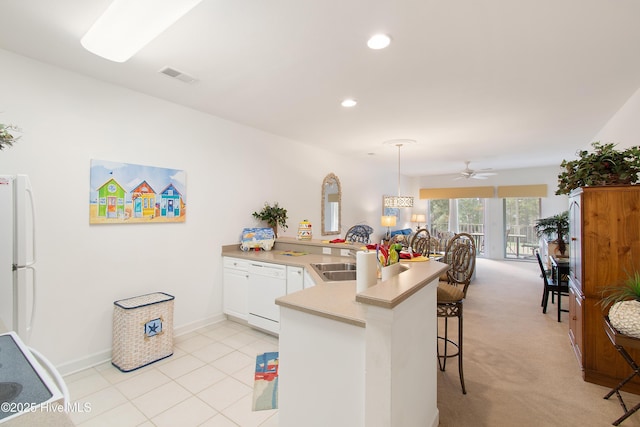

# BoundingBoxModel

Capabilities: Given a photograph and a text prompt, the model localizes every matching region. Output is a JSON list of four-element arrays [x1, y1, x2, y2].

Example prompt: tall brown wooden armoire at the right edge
[[569, 185, 640, 394]]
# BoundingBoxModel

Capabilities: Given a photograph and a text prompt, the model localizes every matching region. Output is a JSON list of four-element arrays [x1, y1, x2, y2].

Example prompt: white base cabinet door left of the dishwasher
[[222, 257, 249, 320]]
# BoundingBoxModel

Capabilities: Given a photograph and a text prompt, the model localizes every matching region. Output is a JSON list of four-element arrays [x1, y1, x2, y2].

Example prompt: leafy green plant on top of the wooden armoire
[[556, 142, 640, 195]]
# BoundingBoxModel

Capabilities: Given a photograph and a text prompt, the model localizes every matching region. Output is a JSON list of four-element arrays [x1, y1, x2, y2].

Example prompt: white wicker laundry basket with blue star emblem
[[111, 292, 174, 372]]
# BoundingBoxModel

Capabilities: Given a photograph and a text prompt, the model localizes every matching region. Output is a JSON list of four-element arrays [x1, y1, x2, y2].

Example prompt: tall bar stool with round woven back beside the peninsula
[[437, 233, 476, 394]]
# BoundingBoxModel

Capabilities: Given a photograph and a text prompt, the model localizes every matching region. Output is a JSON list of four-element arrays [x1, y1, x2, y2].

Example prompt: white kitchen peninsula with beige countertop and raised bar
[[222, 238, 447, 427]]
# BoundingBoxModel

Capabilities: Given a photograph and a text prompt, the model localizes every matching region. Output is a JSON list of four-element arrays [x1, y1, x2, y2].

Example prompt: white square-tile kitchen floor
[[65, 321, 278, 427]]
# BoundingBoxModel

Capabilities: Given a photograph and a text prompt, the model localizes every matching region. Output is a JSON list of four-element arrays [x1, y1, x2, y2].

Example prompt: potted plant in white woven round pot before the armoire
[[600, 271, 640, 338]]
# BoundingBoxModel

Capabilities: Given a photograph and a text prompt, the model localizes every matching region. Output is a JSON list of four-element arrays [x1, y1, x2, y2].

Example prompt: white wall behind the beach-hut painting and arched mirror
[[0, 50, 397, 372]]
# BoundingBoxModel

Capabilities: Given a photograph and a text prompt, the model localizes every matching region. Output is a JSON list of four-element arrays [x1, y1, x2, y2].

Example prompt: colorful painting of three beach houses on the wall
[[89, 160, 187, 224]]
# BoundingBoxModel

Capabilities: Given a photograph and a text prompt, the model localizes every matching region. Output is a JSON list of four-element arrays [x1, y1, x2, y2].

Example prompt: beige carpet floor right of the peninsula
[[434, 259, 640, 427]]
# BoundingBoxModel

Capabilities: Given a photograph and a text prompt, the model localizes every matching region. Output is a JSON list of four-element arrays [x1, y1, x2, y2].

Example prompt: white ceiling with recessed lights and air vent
[[0, 0, 640, 176]]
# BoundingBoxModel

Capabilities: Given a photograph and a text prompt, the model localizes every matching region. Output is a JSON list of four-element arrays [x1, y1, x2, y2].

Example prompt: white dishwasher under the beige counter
[[248, 261, 287, 334]]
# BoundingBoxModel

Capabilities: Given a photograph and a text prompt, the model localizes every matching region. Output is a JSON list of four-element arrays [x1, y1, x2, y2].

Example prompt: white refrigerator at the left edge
[[0, 175, 36, 343]]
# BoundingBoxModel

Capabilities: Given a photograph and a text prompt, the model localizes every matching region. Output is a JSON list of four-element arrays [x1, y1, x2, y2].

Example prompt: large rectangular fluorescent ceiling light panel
[[80, 0, 202, 62]]
